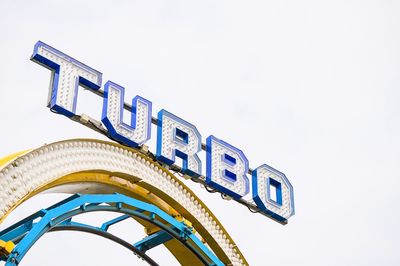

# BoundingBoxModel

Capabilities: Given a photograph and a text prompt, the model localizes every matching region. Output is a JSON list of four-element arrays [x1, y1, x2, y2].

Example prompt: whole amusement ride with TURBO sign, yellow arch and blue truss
[[0, 42, 294, 266]]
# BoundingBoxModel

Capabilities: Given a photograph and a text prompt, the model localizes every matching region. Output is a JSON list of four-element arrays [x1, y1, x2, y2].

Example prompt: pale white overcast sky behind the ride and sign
[[0, 0, 400, 266]]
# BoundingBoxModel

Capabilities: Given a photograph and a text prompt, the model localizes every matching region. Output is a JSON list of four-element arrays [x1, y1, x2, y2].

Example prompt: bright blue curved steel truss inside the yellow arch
[[0, 193, 224, 266]]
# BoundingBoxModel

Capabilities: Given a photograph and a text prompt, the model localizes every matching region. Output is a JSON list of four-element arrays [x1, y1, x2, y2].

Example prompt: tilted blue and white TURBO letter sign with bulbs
[[32, 41, 295, 224]]
